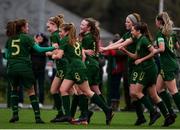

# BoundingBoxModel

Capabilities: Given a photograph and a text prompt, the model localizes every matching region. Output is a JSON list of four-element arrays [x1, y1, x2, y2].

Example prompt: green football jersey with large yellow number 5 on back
[[5, 33, 35, 71]]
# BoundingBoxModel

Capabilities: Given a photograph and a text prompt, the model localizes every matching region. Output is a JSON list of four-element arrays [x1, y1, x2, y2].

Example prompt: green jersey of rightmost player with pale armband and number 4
[[156, 30, 178, 71]]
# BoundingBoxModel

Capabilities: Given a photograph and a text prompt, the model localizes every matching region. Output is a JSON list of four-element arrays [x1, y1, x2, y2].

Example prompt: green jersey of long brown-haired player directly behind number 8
[[82, 33, 99, 67]]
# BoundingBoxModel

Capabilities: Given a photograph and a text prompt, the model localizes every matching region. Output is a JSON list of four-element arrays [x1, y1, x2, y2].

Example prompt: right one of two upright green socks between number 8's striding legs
[[79, 95, 88, 118]]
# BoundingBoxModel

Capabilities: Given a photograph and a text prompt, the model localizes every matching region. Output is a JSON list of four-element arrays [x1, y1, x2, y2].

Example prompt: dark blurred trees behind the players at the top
[[51, 0, 180, 35]]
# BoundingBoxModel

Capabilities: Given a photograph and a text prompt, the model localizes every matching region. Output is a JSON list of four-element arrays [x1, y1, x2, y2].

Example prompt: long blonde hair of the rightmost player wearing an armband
[[156, 12, 173, 36]]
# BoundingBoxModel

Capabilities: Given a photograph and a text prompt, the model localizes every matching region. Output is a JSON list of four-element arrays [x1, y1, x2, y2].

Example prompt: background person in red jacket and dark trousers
[[104, 34, 128, 111]]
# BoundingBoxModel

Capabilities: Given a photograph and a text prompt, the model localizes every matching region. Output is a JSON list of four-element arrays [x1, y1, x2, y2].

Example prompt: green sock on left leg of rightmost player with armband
[[159, 91, 174, 114]]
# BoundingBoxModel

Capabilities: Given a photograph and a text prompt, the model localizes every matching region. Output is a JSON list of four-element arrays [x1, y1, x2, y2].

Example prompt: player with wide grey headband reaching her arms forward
[[100, 13, 146, 125]]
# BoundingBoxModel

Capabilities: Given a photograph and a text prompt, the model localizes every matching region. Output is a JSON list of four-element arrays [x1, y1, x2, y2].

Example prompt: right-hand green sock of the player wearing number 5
[[29, 95, 40, 119]]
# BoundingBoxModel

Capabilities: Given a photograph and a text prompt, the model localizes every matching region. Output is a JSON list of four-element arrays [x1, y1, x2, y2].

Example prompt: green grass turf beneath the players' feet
[[0, 109, 180, 129]]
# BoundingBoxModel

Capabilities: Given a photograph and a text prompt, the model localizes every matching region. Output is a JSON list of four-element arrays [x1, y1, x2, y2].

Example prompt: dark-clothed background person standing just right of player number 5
[[31, 33, 48, 108]]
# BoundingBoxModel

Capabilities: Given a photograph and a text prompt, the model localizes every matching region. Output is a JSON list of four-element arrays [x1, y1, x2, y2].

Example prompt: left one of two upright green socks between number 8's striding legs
[[71, 95, 79, 117]]
